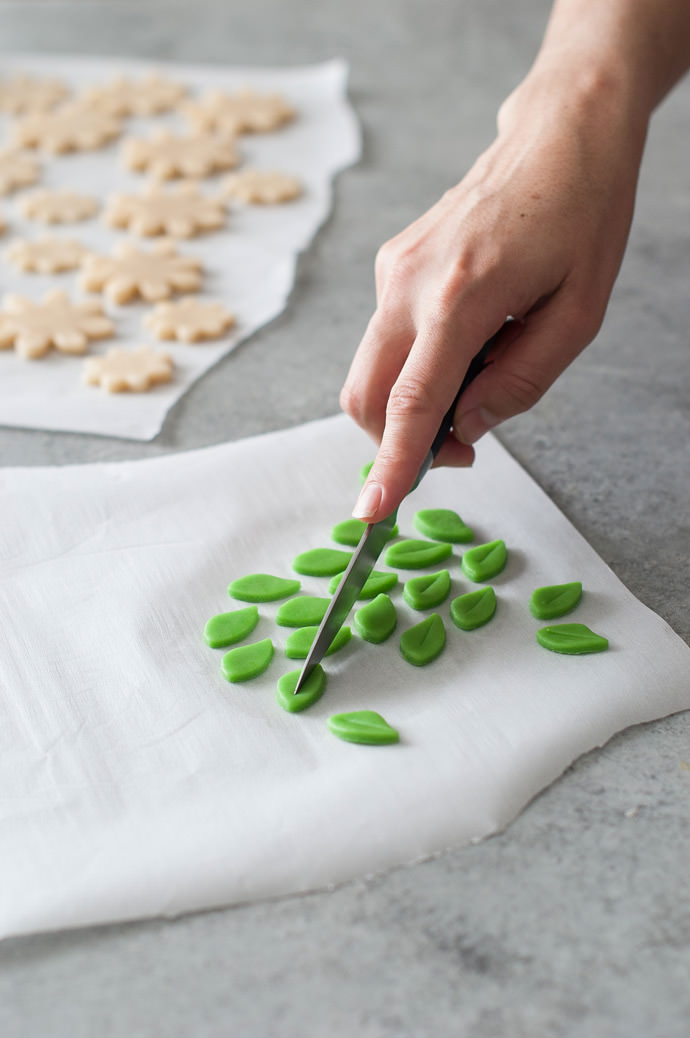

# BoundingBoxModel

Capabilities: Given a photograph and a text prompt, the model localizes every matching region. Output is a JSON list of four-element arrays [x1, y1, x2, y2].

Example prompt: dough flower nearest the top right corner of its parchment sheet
[[182, 89, 296, 133]]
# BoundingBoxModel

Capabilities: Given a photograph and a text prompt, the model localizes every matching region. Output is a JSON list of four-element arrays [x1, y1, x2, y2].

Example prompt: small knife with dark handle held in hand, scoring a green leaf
[[295, 333, 498, 695]]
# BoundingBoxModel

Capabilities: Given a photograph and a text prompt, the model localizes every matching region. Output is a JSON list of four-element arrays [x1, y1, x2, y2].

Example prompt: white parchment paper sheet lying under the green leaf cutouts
[[0, 416, 690, 935]]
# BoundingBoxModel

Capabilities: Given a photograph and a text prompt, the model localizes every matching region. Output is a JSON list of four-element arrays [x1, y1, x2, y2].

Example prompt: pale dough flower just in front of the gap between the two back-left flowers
[[12, 102, 122, 155]]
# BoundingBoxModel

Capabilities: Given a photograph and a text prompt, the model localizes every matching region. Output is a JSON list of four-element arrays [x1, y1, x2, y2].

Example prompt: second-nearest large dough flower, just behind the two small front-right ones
[[81, 235, 201, 303]]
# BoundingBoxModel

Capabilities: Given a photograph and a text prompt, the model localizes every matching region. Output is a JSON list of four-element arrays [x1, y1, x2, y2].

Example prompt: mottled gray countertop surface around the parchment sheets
[[0, 0, 690, 1038]]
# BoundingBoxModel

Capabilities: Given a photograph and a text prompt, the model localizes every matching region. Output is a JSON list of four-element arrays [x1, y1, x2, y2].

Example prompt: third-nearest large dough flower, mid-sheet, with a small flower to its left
[[104, 181, 226, 238]]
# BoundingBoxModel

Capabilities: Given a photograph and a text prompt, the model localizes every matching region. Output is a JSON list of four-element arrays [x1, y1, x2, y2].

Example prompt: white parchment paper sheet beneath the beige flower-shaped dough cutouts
[[0, 55, 360, 440]]
